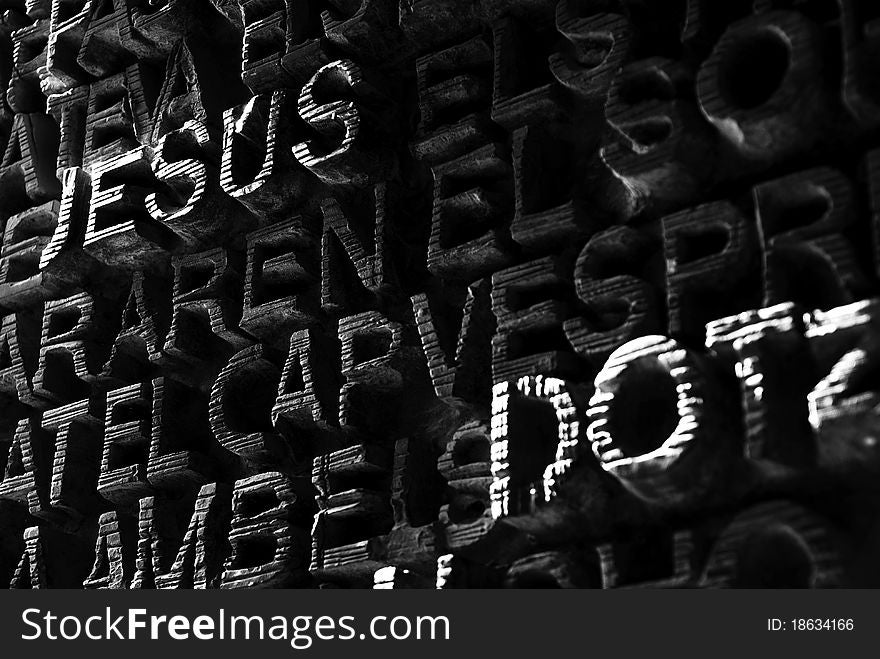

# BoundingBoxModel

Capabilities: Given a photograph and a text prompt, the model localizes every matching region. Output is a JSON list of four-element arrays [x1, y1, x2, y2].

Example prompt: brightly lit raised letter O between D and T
[[587, 335, 743, 503]]
